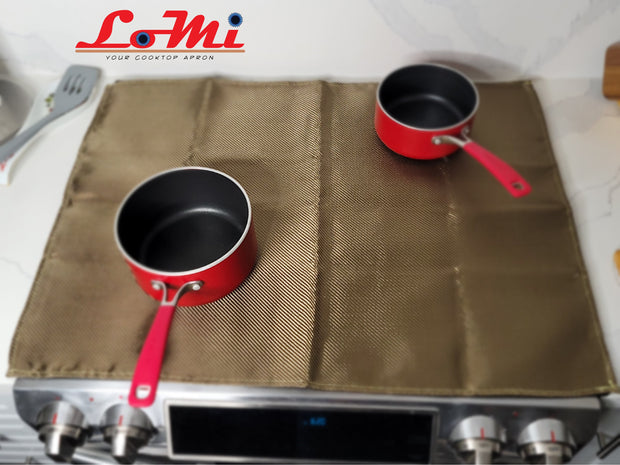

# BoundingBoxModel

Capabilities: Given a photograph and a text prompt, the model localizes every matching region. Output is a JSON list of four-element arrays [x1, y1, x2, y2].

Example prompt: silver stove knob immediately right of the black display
[[450, 415, 506, 464]]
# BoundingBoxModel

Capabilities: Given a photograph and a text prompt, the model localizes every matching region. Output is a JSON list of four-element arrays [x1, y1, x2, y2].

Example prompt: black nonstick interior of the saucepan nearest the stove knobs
[[117, 169, 250, 272]]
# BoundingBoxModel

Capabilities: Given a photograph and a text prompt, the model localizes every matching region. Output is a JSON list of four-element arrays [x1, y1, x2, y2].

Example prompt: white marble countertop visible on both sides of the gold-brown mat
[[0, 76, 620, 390]]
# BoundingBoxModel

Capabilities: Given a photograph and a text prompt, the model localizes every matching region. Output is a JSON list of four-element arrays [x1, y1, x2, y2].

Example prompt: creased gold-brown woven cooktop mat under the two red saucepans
[[8, 79, 617, 396]]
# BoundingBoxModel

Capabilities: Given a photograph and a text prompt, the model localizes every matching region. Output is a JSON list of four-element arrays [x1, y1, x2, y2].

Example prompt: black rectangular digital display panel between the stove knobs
[[168, 405, 433, 463]]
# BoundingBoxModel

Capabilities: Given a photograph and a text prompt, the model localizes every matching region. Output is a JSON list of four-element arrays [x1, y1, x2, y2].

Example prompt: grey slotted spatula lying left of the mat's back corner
[[0, 65, 101, 163]]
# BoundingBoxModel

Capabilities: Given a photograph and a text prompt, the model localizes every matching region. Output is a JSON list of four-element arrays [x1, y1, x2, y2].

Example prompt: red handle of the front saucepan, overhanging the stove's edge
[[129, 303, 176, 407]]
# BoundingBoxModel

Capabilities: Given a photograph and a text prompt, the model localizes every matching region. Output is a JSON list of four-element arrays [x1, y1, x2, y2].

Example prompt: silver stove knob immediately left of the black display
[[101, 404, 155, 463]]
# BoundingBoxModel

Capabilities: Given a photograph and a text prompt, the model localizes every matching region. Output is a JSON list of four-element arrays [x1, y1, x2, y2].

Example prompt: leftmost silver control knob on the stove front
[[35, 401, 90, 462]]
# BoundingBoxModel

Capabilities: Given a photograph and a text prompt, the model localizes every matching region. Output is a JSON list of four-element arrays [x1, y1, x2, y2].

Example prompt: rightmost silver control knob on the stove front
[[517, 418, 575, 463]]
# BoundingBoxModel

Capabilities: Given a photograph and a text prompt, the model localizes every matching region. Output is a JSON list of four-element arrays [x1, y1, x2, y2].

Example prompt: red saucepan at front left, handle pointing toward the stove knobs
[[115, 167, 256, 407]]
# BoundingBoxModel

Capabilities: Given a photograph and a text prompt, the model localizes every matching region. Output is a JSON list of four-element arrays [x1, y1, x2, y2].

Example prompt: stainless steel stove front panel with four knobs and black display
[[10, 379, 617, 463]]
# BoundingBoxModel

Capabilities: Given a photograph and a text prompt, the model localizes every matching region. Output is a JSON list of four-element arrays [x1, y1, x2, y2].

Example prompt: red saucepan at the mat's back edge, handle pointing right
[[375, 63, 531, 197]]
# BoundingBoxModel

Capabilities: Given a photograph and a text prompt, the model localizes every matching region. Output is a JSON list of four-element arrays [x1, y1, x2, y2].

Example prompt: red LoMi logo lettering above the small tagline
[[75, 10, 245, 53]]
